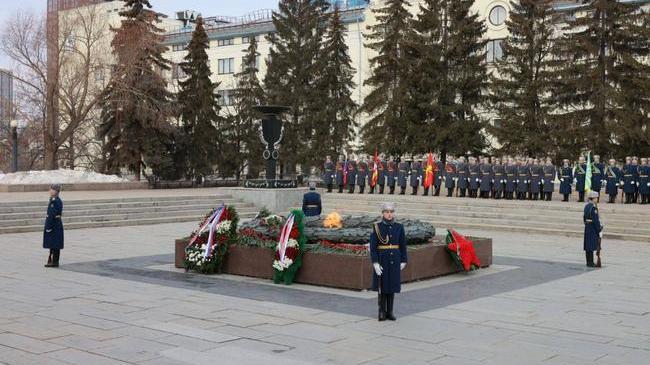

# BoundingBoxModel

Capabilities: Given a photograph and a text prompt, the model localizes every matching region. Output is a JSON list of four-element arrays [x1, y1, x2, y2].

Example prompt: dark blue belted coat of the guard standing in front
[[370, 220, 407, 294]]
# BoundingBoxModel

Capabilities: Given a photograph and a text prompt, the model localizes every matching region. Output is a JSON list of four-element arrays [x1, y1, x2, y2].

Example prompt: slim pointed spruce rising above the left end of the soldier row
[[314, 6, 357, 156]]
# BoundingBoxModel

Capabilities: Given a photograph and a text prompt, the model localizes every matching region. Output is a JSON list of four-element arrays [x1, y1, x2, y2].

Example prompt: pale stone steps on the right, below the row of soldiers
[[322, 193, 650, 243]]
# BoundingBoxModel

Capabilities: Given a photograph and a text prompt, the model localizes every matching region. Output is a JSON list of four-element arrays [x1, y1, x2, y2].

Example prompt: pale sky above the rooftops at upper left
[[0, 0, 278, 68]]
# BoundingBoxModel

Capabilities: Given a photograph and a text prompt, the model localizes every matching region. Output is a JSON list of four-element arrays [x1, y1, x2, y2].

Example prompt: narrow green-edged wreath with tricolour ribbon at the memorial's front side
[[273, 209, 307, 285]]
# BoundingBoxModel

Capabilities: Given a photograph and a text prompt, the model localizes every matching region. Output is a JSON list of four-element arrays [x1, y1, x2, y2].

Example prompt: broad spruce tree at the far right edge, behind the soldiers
[[555, 0, 649, 157]]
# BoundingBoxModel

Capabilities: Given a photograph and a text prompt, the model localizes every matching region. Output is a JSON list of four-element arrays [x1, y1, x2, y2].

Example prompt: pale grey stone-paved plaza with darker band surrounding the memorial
[[0, 212, 650, 365]]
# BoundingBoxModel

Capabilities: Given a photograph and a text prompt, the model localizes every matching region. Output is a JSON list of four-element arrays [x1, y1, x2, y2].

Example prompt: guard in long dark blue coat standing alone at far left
[[43, 184, 63, 267]]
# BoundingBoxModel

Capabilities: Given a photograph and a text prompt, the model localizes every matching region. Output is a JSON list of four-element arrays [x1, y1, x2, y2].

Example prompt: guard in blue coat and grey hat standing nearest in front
[[370, 203, 408, 321]]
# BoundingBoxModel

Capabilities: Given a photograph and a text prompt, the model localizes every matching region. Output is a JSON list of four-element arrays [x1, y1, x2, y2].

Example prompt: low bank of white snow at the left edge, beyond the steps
[[0, 169, 129, 185]]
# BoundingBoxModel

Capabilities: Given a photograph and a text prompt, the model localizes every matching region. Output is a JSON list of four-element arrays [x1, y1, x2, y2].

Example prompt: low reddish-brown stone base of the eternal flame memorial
[[175, 237, 492, 290]]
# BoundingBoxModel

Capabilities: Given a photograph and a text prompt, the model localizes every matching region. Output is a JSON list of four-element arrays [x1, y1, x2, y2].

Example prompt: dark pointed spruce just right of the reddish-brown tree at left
[[178, 17, 224, 178]]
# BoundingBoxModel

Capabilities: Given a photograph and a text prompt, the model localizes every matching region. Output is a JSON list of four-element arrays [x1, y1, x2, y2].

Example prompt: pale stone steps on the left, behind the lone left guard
[[0, 193, 258, 234]]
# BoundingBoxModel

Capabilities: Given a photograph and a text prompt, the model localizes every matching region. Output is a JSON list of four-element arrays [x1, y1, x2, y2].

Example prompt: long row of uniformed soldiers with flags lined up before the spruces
[[323, 155, 650, 204]]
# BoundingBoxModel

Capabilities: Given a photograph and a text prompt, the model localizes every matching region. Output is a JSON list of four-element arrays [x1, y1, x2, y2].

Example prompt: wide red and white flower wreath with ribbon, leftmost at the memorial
[[184, 205, 239, 274]]
